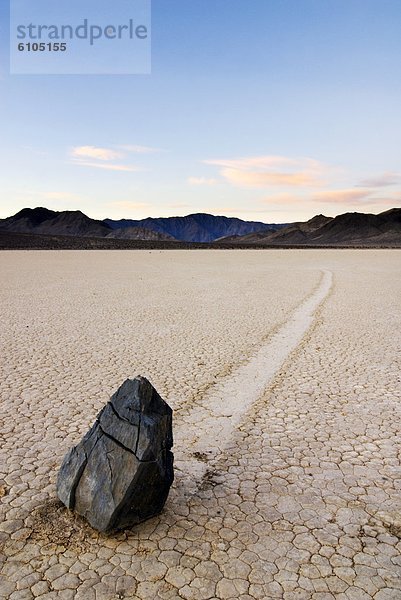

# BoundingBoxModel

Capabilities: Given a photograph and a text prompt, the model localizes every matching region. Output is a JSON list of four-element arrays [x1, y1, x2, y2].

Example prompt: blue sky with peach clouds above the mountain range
[[0, 0, 401, 223]]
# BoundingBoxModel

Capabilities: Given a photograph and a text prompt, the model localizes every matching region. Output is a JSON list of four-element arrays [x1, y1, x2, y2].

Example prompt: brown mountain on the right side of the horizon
[[222, 208, 401, 246]]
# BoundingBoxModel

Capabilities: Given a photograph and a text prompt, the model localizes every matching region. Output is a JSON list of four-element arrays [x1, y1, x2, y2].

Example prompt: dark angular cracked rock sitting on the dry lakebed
[[57, 377, 174, 532]]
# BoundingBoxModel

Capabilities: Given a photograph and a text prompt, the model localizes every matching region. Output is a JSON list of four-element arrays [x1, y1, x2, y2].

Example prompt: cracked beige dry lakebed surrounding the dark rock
[[0, 250, 401, 600]]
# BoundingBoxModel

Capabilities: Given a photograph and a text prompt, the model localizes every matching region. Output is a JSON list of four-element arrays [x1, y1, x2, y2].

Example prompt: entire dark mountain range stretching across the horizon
[[0, 208, 401, 247]]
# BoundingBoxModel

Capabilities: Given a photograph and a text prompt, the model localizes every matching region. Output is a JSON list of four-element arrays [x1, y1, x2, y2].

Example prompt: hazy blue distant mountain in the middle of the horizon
[[104, 213, 285, 242]]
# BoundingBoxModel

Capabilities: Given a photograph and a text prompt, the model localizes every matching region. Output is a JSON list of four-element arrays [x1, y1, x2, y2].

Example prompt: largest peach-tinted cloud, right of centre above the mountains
[[203, 155, 328, 188]]
